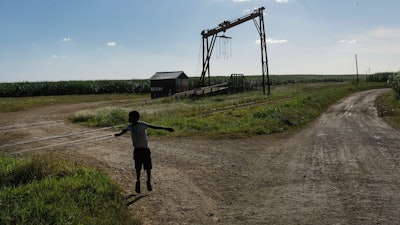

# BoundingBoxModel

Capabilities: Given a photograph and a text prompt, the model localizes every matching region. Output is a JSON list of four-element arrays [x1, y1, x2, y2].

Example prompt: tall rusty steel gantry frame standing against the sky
[[200, 7, 270, 95]]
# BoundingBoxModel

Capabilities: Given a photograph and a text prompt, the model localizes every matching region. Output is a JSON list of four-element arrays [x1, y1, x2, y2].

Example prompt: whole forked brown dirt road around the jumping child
[[0, 90, 400, 225]]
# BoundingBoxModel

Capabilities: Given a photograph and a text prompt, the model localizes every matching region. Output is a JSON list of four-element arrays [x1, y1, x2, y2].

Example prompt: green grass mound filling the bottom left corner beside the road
[[0, 156, 140, 224]]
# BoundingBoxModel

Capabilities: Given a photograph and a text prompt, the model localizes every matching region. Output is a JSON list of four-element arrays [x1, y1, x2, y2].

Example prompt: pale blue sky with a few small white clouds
[[0, 0, 400, 82]]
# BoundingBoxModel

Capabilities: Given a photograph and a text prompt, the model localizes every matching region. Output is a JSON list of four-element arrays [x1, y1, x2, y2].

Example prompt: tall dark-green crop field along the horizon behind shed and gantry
[[0, 75, 364, 98]]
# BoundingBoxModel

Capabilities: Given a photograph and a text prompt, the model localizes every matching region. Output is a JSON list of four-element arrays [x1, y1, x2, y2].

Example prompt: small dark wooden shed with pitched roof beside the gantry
[[150, 71, 189, 99]]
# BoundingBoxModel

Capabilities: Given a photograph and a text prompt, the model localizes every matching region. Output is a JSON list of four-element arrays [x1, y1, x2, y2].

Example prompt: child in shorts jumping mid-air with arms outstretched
[[115, 111, 174, 193]]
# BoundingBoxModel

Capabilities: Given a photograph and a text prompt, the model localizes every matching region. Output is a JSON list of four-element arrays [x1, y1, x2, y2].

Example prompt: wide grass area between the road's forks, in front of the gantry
[[70, 82, 387, 138]]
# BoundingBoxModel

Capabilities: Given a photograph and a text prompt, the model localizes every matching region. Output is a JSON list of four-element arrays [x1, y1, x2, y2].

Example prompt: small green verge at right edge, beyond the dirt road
[[376, 91, 400, 130]]
